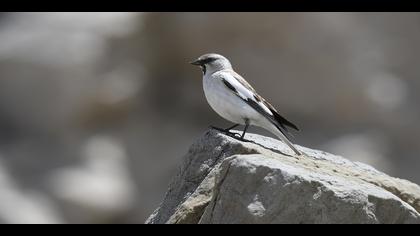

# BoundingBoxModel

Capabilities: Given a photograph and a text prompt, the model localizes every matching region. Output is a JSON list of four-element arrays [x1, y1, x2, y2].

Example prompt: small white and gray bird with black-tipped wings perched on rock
[[190, 53, 302, 156]]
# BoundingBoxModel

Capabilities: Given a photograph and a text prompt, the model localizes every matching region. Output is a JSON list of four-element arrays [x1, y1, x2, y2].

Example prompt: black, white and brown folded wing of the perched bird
[[222, 70, 299, 132]]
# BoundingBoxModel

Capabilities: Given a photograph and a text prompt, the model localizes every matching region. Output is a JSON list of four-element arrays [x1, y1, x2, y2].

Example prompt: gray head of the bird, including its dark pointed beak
[[190, 53, 232, 74]]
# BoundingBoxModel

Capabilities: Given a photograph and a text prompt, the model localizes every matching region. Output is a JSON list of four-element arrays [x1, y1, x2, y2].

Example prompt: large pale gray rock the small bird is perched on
[[146, 130, 420, 224]]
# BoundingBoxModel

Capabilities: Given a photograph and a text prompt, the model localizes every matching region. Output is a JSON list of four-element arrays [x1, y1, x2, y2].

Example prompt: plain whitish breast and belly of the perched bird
[[204, 77, 259, 125]]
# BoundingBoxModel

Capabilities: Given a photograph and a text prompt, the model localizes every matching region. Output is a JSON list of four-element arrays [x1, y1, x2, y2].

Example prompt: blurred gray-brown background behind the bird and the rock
[[0, 13, 420, 223]]
